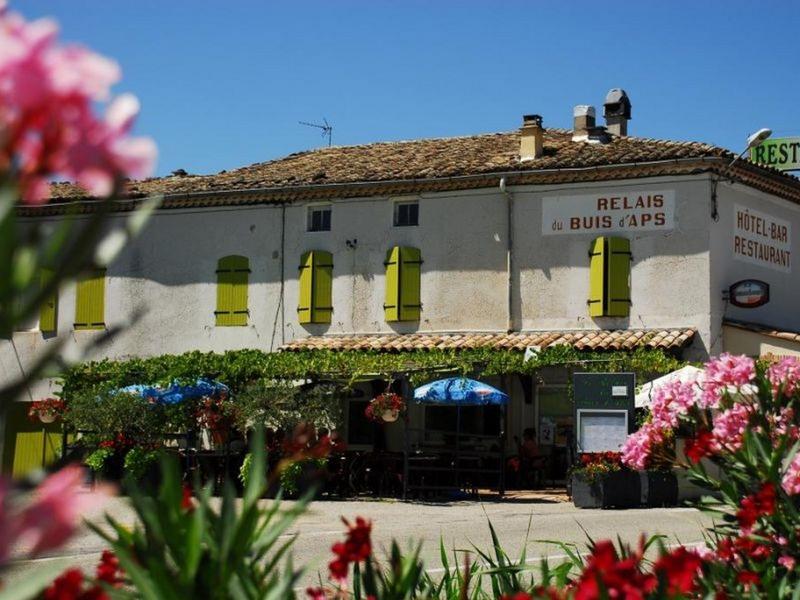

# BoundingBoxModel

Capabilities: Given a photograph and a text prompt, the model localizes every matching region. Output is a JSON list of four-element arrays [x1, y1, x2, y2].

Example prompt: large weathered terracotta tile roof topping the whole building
[[34, 129, 800, 210]]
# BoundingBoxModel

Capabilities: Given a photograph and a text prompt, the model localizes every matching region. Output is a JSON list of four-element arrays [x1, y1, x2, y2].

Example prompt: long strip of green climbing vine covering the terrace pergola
[[61, 345, 686, 398]]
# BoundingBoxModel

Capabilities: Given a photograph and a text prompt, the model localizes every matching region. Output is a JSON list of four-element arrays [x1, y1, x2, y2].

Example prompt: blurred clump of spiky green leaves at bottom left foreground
[[90, 434, 306, 600]]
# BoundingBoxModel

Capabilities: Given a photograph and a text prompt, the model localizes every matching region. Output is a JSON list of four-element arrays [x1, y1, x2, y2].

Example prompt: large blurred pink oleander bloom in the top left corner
[[0, 3, 156, 203]]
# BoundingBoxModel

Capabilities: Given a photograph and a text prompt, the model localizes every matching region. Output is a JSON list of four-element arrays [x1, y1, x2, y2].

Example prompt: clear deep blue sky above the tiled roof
[[17, 0, 800, 174]]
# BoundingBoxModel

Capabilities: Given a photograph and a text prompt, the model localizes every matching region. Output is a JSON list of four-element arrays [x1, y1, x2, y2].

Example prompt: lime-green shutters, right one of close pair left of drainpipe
[[383, 246, 422, 323]]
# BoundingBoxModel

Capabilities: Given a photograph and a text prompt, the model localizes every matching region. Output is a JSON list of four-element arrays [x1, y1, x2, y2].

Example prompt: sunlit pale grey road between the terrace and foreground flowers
[[7, 491, 711, 586]]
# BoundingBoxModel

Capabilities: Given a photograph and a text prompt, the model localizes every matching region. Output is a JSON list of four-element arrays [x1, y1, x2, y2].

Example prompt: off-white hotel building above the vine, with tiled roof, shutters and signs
[[0, 90, 800, 482]]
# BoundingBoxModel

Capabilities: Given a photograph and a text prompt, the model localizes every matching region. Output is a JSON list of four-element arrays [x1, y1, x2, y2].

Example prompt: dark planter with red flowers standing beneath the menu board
[[570, 452, 641, 508]]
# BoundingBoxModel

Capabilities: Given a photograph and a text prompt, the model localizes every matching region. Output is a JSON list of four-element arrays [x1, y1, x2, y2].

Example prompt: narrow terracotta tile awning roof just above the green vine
[[281, 329, 695, 352]]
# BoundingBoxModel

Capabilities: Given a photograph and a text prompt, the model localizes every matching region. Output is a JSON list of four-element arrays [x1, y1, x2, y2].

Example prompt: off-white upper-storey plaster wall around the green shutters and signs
[[6, 171, 800, 404]]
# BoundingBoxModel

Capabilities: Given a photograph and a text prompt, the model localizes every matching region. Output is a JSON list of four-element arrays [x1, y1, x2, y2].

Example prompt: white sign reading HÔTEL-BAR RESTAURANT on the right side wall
[[733, 204, 792, 273]]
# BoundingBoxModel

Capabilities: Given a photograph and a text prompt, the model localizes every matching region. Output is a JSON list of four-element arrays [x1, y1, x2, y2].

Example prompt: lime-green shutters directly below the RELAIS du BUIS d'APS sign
[[589, 237, 631, 317]]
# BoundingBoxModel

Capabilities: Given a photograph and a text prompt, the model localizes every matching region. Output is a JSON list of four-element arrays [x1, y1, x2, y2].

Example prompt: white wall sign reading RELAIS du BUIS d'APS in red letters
[[542, 190, 675, 235]]
